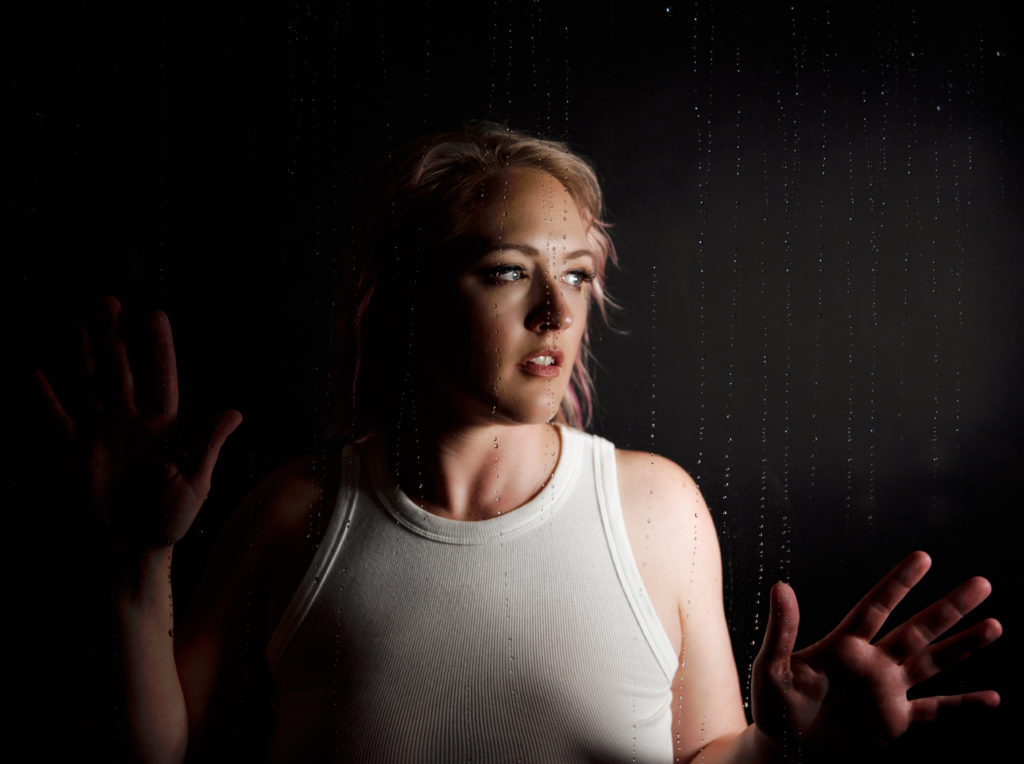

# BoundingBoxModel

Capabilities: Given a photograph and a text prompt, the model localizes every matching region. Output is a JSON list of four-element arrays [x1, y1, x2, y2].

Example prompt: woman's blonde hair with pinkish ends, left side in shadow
[[345, 122, 615, 435]]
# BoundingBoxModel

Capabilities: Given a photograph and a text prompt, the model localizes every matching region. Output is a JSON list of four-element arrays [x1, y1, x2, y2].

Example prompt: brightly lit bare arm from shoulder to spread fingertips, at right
[[620, 452, 1001, 764]]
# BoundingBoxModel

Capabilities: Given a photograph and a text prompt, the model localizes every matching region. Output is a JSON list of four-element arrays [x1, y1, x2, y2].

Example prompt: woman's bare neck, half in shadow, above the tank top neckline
[[388, 424, 561, 520]]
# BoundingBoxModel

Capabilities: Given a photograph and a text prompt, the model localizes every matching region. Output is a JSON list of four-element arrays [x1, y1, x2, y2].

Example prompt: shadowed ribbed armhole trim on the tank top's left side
[[266, 443, 359, 673]]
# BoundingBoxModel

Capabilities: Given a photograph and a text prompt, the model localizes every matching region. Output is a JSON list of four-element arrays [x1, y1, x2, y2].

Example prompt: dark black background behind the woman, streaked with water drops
[[2, 0, 1024, 761]]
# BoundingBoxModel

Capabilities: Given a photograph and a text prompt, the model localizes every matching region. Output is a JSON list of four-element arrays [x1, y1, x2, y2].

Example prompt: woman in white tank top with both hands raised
[[37, 125, 1000, 762]]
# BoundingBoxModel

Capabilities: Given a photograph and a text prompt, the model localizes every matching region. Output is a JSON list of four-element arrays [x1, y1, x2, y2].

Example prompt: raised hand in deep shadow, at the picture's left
[[33, 297, 242, 564]]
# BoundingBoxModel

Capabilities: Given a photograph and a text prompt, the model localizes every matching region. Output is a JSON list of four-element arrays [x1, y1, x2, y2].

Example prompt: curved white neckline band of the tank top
[[367, 425, 587, 545]]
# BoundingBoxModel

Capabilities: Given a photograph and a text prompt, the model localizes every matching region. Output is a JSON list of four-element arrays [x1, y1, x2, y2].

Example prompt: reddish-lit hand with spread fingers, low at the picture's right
[[753, 552, 1002, 760]]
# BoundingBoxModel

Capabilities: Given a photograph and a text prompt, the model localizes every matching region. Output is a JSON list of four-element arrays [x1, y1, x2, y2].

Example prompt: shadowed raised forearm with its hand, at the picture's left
[[33, 298, 242, 761]]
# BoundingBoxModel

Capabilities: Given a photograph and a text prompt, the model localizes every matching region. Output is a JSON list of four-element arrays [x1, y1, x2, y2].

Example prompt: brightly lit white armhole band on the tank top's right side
[[594, 437, 679, 682]]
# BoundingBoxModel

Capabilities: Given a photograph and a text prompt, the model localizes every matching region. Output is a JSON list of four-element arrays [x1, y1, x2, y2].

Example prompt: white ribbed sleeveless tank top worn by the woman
[[266, 427, 677, 762]]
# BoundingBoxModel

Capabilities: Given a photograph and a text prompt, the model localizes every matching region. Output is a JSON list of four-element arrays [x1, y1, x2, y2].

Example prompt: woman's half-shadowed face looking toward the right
[[430, 168, 594, 424]]
